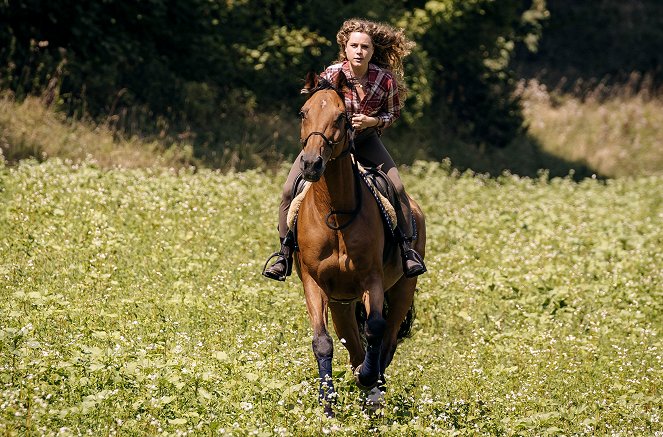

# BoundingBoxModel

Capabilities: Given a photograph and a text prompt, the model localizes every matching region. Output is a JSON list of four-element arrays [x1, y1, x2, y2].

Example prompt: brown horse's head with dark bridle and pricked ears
[[299, 74, 352, 182]]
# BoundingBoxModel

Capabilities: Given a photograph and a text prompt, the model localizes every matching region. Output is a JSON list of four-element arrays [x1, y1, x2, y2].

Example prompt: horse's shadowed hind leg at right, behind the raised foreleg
[[380, 277, 417, 372]]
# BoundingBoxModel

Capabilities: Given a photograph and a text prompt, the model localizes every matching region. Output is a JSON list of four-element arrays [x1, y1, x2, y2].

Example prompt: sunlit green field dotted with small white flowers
[[0, 160, 663, 436]]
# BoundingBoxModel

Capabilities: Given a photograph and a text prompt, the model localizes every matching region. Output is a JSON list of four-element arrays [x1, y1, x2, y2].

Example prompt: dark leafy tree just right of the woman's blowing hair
[[400, 0, 547, 146]]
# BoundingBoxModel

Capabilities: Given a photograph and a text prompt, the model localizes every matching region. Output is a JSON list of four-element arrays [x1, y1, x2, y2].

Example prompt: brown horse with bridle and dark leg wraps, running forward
[[295, 74, 426, 415]]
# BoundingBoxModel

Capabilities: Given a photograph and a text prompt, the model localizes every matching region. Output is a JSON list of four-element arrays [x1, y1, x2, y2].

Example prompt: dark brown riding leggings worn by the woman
[[279, 128, 412, 239]]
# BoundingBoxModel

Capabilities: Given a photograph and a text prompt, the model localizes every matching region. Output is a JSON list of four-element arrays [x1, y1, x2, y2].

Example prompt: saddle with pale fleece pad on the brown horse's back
[[287, 163, 400, 241]]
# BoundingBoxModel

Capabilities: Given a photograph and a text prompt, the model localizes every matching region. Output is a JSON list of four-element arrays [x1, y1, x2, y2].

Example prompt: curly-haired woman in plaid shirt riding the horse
[[263, 19, 426, 281]]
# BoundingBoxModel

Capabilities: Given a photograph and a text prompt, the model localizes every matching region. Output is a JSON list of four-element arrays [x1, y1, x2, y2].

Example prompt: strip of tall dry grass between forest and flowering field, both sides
[[0, 80, 663, 179]]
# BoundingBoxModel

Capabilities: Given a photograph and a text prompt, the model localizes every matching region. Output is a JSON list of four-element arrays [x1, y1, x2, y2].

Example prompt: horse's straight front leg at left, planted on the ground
[[303, 277, 336, 417]]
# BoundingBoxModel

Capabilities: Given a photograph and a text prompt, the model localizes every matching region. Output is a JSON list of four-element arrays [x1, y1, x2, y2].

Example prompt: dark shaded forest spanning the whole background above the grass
[[0, 0, 663, 174]]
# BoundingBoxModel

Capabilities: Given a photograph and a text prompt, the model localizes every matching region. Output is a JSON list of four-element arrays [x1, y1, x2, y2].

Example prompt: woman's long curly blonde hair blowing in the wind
[[336, 18, 415, 96]]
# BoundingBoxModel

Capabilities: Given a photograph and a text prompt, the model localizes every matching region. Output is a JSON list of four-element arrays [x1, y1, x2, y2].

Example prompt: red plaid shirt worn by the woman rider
[[322, 61, 401, 129]]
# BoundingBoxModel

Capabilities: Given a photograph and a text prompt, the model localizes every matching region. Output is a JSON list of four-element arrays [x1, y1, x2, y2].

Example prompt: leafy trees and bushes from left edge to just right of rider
[[0, 0, 545, 154]]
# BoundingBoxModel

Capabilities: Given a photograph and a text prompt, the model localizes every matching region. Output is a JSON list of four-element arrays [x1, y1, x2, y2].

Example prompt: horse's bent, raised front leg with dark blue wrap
[[355, 277, 387, 388]]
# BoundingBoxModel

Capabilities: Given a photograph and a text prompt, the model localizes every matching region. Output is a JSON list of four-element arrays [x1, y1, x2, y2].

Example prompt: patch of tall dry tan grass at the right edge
[[519, 75, 663, 177]]
